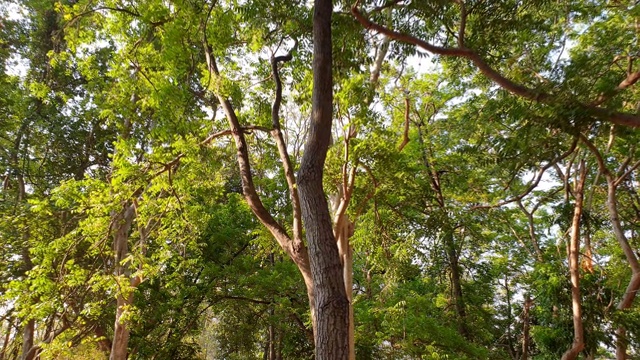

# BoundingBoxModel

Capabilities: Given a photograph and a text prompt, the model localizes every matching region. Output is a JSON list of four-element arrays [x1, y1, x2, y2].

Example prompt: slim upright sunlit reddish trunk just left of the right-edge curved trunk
[[562, 160, 587, 360]]
